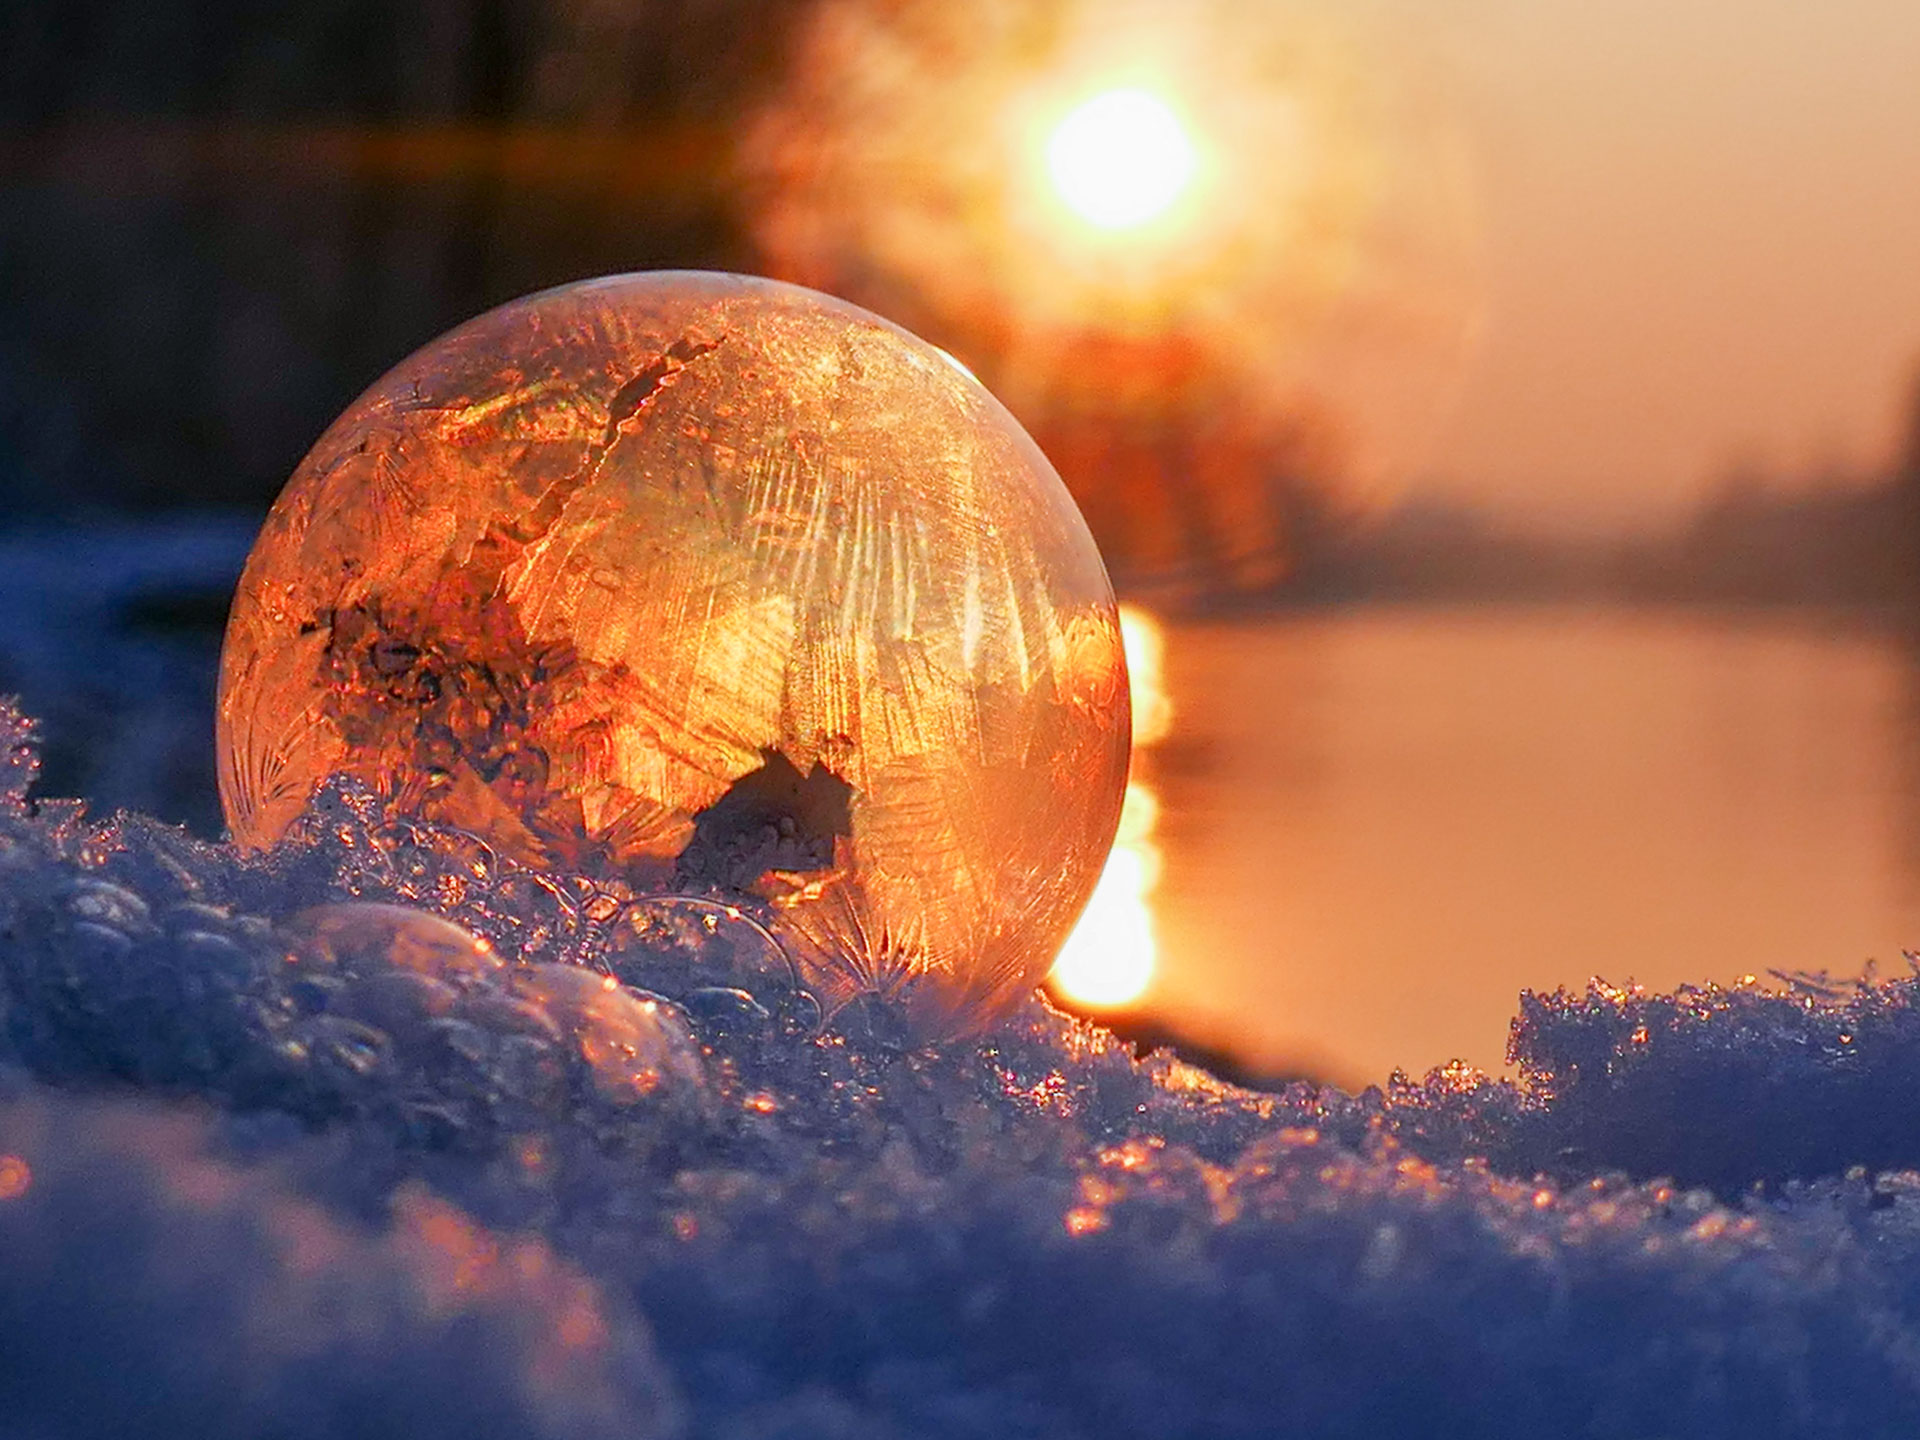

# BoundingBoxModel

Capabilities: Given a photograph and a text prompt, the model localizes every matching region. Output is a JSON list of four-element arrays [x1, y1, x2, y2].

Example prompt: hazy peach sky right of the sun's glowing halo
[[1413, 0, 1920, 524]]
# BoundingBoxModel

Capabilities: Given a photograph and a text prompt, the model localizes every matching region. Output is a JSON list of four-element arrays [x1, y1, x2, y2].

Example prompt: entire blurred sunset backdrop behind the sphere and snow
[[0, 0, 1920, 1085]]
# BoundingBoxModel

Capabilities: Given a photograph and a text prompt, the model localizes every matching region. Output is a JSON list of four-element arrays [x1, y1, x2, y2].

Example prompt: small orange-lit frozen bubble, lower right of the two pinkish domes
[[513, 966, 707, 1106]]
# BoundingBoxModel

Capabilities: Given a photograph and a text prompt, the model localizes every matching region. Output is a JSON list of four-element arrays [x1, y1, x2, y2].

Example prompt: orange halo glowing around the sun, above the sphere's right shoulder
[[739, 0, 1476, 572]]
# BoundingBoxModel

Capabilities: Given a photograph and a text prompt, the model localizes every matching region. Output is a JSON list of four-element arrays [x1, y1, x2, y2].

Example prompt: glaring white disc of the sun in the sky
[[1046, 90, 1194, 230]]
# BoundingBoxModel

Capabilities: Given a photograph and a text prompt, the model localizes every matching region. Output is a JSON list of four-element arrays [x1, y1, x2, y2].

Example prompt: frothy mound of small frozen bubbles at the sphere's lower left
[[0, 779, 737, 1144]]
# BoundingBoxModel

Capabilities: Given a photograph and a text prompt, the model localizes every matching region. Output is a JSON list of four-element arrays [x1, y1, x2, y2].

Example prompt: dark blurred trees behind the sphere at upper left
[[0, 0, 804, 524]]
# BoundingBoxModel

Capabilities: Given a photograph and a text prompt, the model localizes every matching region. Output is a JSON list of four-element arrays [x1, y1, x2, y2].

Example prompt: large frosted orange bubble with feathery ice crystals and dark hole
[[219, 273, 1129, 1033]]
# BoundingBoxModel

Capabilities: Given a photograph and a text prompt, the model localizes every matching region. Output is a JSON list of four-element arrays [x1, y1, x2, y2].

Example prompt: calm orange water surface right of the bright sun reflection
[[1146, 611, 1920, 1083]]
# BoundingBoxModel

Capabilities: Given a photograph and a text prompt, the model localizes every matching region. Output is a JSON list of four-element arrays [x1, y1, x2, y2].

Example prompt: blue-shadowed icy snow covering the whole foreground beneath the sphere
[[0, 695, 1920, 1438]]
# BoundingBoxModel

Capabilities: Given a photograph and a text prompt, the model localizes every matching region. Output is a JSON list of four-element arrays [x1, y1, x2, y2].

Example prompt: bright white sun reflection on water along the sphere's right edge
[[1048, 605, 1173, 1010]]
